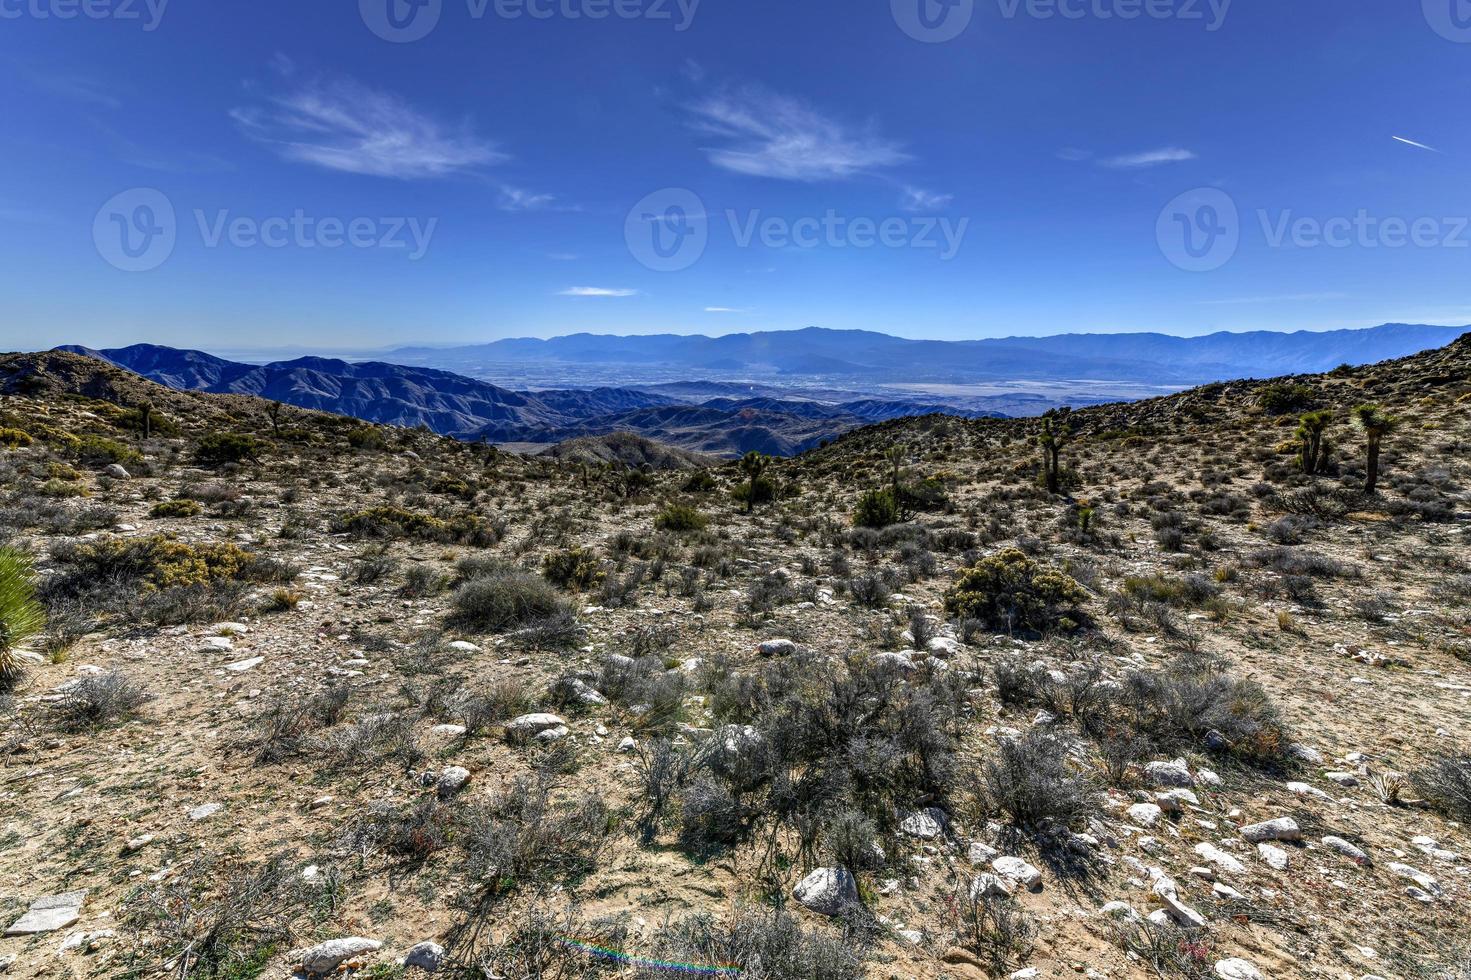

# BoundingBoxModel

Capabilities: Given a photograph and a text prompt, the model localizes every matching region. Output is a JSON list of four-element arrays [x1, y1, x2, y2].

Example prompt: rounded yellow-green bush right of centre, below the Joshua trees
[[944, 547, 1086, 633]]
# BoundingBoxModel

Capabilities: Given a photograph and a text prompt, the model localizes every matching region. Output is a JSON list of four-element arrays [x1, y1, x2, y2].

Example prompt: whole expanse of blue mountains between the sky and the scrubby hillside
[[62, 324, 1465, 456]]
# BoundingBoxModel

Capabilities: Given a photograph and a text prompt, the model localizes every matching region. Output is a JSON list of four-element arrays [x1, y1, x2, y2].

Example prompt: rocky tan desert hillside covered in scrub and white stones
[[0, 338, 1471, 980]]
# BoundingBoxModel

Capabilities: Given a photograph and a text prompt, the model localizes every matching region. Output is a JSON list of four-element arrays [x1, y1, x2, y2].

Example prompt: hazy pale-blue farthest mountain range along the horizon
[[385, 324, 1467, 386]]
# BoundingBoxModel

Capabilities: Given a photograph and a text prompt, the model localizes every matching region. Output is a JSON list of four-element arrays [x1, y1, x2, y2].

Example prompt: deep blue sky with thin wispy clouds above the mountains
[[0, 0, 1471, 349]]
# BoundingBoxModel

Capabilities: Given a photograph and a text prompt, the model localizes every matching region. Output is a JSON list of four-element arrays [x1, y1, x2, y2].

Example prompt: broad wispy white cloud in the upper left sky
[[229, 78, 507, 180]]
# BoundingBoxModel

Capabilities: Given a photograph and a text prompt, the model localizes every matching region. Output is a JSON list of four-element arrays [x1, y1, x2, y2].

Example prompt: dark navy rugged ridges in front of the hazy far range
[[60, 344, 984, 456]]
